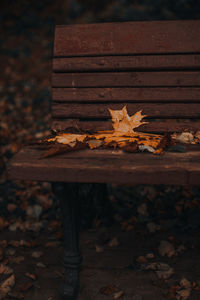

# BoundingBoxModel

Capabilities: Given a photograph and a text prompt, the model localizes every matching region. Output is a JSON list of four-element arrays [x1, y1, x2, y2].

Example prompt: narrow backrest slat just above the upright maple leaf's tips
[[52, 87, 200, 102]]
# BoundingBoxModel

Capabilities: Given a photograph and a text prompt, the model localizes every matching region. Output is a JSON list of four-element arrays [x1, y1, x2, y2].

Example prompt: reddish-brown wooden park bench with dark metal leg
[[8, 20, 200, 300]]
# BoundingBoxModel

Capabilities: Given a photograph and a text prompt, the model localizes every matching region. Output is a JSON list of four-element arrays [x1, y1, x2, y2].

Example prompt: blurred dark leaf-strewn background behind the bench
[[0, 0, 200, 230]]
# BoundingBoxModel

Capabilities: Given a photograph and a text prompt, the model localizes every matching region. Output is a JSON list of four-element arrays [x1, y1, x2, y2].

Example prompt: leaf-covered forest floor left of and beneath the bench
[[0, 0, 200, 300]]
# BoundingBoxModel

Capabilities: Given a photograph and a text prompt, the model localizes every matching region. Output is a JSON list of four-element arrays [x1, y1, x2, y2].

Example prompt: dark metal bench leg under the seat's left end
[[52, 183, 82, 300]]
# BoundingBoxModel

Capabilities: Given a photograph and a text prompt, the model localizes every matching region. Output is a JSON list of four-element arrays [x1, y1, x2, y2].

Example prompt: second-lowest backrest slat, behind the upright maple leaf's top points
[[52, 103, 200, 118]]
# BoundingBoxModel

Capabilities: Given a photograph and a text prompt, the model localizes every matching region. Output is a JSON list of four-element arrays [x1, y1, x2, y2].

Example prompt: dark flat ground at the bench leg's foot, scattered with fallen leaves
[[0, 223, 200, 300]]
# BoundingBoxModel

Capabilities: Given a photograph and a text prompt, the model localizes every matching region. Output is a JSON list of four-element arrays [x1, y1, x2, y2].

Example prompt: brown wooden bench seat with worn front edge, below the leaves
[[8, 147, 200, 184]]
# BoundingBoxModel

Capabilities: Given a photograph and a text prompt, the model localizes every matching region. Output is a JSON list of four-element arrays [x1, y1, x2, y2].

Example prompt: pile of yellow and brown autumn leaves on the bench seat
[[32, 106, 200, 158]]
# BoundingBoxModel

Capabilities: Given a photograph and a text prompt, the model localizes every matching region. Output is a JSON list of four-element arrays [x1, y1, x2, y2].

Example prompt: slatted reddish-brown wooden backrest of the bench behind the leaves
[[52, 20, 200, 132]]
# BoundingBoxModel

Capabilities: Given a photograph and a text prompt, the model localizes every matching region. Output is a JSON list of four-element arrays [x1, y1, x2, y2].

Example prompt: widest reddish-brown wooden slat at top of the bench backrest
[[54, 20, 200, 56]]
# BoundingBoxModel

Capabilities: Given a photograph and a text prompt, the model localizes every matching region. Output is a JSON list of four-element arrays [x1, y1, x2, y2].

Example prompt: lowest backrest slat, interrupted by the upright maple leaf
[[51, 119, 200, 132]]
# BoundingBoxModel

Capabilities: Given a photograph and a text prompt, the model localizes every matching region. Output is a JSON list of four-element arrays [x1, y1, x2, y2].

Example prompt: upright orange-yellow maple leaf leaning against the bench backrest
[[109, 106, 148, 134]]
